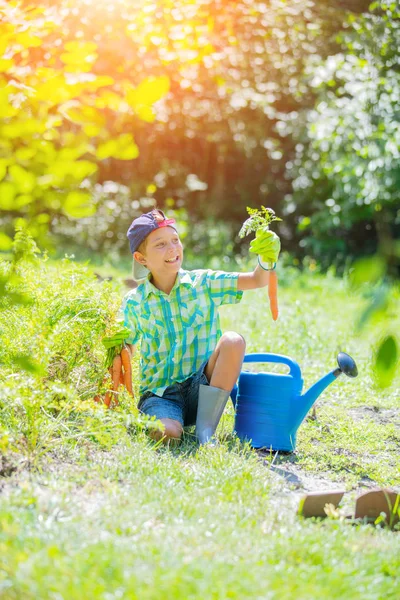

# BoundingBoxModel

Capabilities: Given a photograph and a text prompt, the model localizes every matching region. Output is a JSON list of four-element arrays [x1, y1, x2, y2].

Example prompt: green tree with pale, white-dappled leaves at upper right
[[286, 2, 400, 265]]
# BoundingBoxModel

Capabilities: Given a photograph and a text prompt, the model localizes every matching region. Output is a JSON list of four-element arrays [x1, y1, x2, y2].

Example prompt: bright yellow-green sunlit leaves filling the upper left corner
[[0, 1, 169, 244]]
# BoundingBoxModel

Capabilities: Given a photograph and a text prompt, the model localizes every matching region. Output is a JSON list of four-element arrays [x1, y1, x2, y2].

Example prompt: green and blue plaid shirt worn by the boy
[[122, 269, 243, 396]]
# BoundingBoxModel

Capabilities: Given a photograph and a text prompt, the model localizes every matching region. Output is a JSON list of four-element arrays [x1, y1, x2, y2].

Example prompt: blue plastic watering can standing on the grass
[[231, 352, 358, 452]]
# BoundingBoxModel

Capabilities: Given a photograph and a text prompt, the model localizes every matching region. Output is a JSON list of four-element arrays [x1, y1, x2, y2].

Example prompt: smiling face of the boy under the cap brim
[[133, 227, 183, 276]]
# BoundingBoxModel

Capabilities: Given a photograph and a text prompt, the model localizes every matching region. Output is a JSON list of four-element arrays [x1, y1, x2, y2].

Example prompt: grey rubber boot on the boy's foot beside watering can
[[196, 384, 230, 444]]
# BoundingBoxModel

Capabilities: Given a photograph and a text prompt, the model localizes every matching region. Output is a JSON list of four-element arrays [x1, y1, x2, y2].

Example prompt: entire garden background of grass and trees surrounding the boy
[[0, 0, 400, 599]]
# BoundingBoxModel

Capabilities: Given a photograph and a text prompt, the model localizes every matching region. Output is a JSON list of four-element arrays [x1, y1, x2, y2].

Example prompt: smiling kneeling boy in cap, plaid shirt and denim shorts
[[122, 209, 280, 444]]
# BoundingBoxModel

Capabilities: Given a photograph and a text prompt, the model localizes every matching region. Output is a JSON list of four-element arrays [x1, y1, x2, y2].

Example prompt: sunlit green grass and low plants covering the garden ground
[[0, 248, 400, 600]]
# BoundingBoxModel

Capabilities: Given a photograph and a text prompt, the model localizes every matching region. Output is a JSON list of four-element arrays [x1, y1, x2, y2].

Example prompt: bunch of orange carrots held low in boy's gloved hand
[[95, 329, 133, 408]]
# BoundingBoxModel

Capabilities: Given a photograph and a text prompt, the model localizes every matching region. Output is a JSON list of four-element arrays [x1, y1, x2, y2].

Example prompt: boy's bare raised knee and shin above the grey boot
[[204, 331, 246, 392]]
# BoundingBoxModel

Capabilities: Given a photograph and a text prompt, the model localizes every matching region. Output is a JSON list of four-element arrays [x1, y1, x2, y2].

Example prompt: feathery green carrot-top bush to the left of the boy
[[0, 236, 148, 460]]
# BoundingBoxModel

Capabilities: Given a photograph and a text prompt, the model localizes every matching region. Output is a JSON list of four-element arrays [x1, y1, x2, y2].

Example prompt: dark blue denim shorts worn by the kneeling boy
[[138, 360, 209, 427]]
